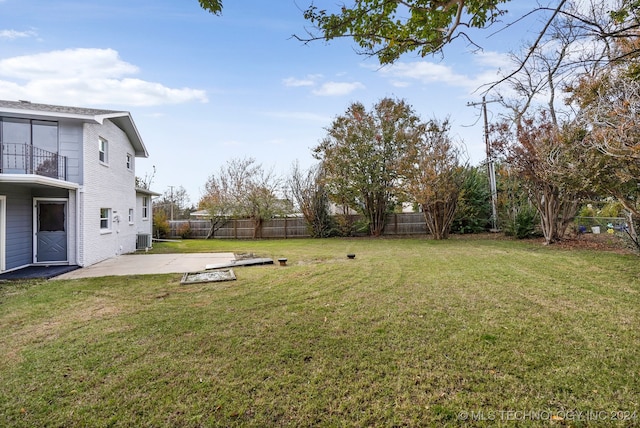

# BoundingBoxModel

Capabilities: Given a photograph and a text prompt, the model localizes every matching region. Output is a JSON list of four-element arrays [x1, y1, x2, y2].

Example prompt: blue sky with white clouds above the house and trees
[[0, 0, 537, 204]]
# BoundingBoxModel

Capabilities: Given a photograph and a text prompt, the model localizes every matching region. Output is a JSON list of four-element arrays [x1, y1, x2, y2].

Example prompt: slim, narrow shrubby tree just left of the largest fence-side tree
[[288, 161, 334, 238]]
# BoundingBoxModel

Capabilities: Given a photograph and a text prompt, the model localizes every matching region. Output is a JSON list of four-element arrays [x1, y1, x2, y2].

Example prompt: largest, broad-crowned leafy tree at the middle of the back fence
[[313, 98, 421, 236]]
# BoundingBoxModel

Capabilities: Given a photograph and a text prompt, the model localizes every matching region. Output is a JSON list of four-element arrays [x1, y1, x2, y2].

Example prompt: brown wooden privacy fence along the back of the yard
[[169, 213, 427, 239]]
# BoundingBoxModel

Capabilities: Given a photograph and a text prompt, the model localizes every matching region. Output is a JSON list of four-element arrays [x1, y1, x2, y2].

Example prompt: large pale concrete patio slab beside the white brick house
[[54, 253, 235, 279]]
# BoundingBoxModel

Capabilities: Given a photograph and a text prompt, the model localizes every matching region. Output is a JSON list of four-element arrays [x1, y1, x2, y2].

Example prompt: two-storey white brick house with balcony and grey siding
[[0, 100, 156, 272]]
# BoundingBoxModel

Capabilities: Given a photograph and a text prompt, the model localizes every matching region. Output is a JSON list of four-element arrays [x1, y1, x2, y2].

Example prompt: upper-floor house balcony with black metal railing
[[0, 143, 67, 180]]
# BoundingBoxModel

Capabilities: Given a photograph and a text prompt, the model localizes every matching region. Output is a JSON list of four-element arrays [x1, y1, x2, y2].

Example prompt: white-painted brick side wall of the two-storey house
[[80, 120, 138, 266]]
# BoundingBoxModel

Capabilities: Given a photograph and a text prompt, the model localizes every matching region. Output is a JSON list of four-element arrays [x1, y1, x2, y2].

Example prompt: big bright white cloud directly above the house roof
[[0, 49, 208, 106]]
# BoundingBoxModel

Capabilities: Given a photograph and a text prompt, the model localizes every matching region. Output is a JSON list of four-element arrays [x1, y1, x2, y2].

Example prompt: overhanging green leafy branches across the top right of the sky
[[294, 0, 640, 89]]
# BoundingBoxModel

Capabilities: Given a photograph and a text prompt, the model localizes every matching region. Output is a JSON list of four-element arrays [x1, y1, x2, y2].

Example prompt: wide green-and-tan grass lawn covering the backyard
[[0, 239, 640, 427]]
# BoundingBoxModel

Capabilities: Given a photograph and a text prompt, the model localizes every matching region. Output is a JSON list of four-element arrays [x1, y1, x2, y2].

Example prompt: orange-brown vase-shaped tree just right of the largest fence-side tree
[[402, 120, 465, 239]]
